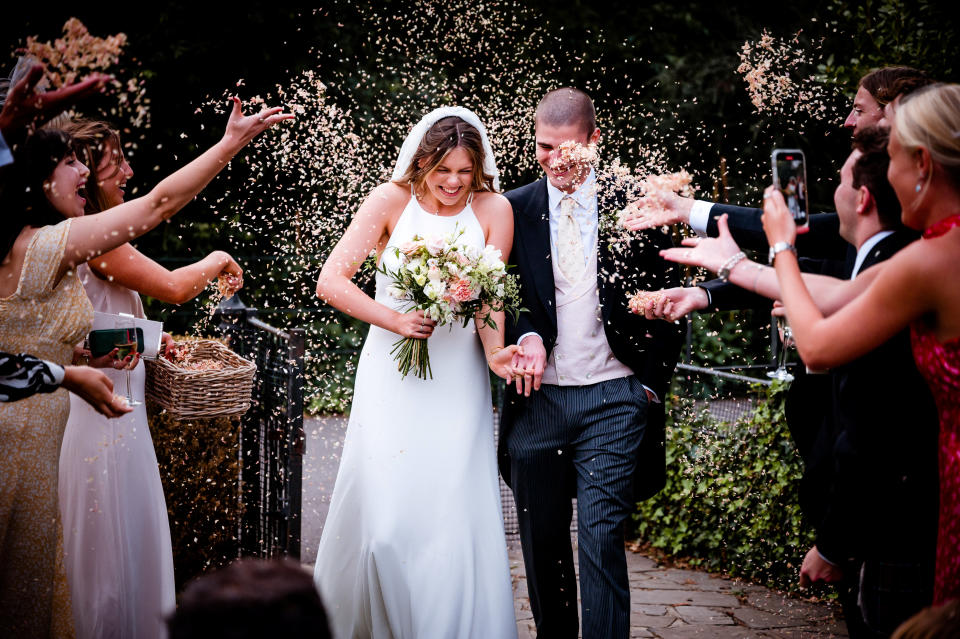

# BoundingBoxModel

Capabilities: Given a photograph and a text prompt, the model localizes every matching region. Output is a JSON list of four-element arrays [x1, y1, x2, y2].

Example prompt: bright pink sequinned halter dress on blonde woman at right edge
[[910, 216, 960, 603]]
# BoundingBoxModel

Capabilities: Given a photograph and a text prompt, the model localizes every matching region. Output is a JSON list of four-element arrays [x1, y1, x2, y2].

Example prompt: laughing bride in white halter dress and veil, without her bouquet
[[314, 107, 517, 639]]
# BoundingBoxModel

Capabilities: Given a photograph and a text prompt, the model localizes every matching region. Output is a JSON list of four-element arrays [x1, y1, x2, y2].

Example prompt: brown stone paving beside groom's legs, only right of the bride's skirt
[[510, 548, 847, 639]]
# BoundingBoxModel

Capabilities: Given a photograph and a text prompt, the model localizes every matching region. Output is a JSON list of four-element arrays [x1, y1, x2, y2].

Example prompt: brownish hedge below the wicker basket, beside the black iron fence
[[148, 404, 242, 591]]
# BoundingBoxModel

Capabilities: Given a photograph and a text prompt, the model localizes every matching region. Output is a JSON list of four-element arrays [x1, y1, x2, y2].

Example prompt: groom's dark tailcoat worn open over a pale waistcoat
[[499, 178, 682, 499]]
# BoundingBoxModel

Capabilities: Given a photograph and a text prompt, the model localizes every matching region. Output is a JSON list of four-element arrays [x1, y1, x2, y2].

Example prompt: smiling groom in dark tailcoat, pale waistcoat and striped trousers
[[500, 88, 680, 639]]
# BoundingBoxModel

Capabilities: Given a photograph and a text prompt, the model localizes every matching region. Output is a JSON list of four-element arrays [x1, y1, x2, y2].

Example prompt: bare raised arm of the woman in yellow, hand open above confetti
[[57, 98, 293, 280]]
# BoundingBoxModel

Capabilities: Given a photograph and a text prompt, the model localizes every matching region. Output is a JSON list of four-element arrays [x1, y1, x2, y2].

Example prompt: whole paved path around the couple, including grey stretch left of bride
[[302, 418, 846, 639]]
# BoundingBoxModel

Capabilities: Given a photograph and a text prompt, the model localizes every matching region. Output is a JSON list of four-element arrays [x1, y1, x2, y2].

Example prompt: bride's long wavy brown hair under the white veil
[[394, 115, 496, 195]]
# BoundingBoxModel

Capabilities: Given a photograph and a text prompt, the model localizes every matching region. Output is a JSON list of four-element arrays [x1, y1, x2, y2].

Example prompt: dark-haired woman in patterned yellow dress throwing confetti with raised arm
[[0, 99, 293, 638]]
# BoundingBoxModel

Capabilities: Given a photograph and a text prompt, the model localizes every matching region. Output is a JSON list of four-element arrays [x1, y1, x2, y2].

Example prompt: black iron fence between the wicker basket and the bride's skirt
[[215, 296, 306, 559]]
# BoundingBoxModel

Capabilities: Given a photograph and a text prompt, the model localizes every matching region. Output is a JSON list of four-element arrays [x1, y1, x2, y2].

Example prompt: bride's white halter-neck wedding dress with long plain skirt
[[314, 198, 517, 639]]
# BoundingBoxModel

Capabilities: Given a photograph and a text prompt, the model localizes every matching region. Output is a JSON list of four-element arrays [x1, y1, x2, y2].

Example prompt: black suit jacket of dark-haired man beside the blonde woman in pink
[[800, 230, 939, 567]]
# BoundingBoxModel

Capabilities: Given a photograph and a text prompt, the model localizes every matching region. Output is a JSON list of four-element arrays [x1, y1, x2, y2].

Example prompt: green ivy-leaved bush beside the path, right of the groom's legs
[[634, 385, 813, 591]]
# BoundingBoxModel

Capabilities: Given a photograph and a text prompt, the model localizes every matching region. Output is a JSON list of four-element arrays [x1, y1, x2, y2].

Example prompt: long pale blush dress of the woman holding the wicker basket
[[59, 264, 176, 639]]
